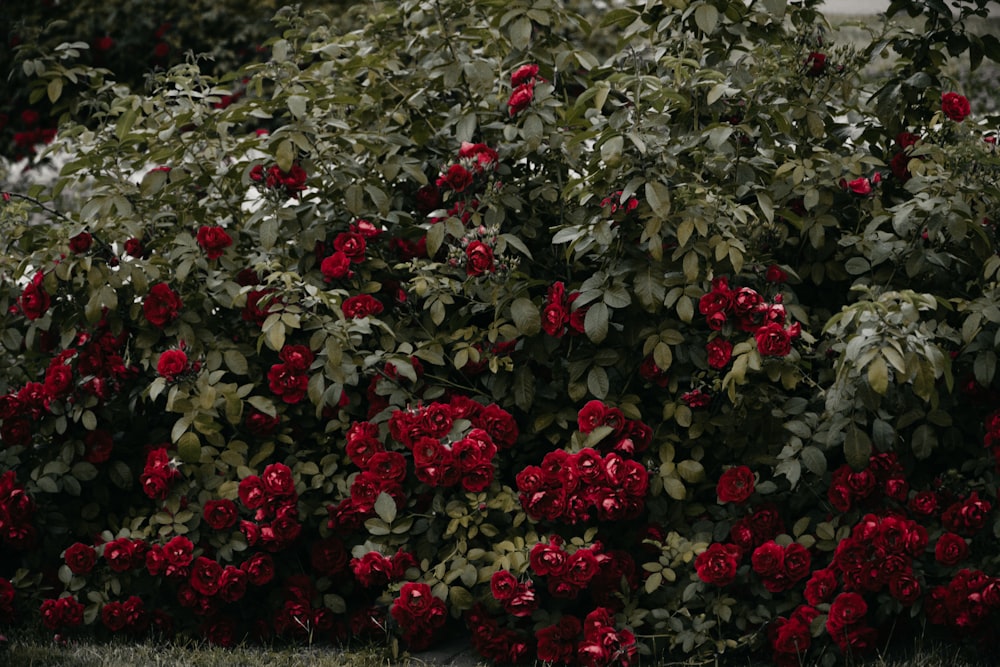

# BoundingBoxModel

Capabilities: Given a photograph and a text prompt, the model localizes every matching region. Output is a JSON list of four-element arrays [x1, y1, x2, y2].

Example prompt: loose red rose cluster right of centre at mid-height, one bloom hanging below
[[698, 277, 801, 358]]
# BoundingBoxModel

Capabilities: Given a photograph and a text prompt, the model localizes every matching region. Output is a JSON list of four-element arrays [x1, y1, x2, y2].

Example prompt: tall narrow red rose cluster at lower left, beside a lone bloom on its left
[[238, 463, 302, 552]]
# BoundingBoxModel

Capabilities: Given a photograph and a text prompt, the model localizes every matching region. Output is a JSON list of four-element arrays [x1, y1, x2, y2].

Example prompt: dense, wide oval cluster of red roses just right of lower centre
[[516, 448, 649, 524]]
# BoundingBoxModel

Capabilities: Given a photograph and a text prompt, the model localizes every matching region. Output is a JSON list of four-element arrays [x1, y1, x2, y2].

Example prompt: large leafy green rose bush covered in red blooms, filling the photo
[[0, 0, 1000, 665]]
